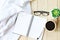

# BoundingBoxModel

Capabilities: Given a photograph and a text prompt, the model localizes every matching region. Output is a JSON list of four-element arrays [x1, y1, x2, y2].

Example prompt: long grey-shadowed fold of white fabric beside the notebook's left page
[[0, 14, 17, 37]]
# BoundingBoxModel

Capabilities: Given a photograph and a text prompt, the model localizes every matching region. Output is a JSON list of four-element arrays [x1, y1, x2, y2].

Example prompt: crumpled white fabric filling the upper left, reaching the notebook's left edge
[[0, 0, 31, 37]]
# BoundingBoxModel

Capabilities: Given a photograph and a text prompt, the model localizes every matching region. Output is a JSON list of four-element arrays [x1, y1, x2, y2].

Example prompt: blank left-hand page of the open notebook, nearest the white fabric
[[14, 13, 32, 36]]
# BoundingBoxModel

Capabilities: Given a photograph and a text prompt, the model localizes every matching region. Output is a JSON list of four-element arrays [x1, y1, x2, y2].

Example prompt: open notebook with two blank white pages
[[13, 14, 47, 39]]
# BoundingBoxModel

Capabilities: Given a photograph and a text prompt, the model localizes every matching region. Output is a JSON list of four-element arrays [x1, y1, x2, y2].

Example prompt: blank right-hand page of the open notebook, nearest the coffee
[[29, 16, 47, 39]]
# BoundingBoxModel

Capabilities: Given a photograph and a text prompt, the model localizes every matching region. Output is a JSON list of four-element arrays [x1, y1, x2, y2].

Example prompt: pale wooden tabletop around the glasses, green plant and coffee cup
[[31, 0, 60, 40]]
